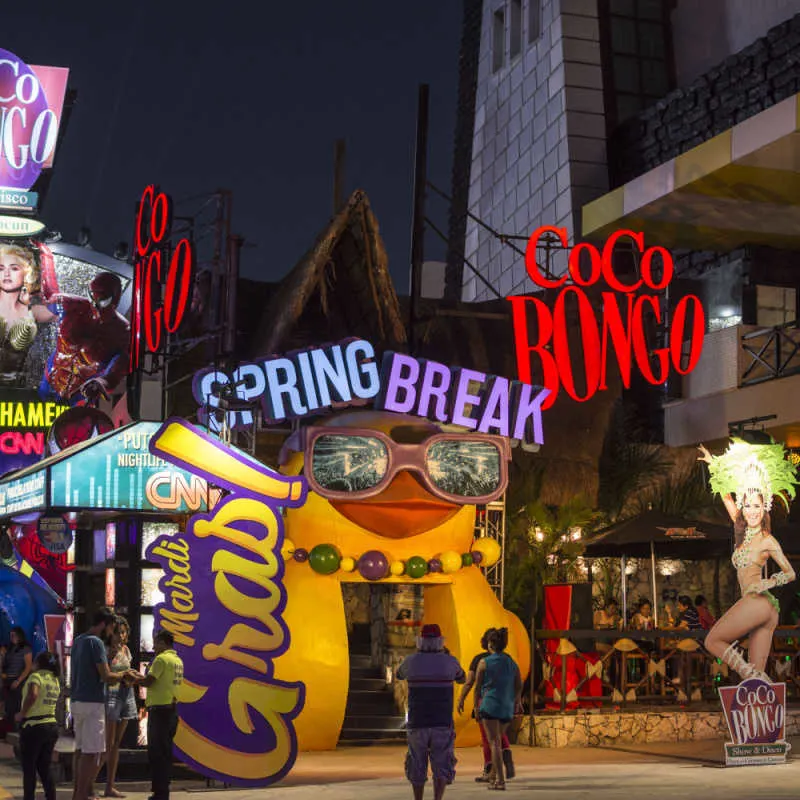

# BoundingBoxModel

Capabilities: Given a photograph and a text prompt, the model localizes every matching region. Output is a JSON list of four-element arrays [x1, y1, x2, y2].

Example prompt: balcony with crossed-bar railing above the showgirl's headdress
[[664, 321, 800, 447]]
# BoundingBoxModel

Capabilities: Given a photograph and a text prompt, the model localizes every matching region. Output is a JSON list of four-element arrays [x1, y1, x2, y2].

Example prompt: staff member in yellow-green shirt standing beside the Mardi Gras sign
[[134, 630, 183, 800]]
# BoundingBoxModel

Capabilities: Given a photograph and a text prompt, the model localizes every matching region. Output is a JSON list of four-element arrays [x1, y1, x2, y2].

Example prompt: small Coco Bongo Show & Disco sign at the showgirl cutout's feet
[[719, 678, 790, 767]]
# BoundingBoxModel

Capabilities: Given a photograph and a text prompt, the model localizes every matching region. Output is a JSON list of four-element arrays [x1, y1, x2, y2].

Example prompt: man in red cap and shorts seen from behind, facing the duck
[[397, 625, 466, 800]]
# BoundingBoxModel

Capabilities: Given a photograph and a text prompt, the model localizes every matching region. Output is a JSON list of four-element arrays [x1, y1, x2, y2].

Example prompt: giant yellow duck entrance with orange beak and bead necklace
[[275, 411, 530, 751]]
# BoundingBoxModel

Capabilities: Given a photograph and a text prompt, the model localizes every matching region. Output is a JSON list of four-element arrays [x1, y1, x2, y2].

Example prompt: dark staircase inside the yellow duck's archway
[[339, 624, 406, 747]]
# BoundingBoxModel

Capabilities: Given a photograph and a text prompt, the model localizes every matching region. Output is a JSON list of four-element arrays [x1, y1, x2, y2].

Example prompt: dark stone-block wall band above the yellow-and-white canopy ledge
[[609, 14, 800, 186]]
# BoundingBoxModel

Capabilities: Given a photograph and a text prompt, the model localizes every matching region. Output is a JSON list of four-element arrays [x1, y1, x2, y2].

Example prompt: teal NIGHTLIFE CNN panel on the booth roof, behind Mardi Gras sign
[[50, 422, 208, 513]]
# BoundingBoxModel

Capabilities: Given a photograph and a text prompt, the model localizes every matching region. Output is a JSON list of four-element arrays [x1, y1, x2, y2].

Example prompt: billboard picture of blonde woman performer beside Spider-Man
[[0, 239, 129, 405]]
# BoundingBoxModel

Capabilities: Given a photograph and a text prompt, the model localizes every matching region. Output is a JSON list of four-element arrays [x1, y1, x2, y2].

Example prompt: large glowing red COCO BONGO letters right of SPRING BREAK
[[506, 225, 705, 409]]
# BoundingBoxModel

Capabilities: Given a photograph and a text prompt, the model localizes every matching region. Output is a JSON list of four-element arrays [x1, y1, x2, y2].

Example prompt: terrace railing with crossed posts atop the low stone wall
[[531, 628, 800, 712]]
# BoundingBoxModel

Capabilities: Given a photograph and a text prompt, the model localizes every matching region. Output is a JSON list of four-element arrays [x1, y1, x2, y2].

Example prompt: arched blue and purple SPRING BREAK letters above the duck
[[193, 339, 549, 444]]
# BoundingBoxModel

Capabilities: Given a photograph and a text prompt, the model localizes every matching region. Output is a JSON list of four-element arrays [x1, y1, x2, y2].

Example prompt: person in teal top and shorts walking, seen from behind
[[475, 628, 522, 790]]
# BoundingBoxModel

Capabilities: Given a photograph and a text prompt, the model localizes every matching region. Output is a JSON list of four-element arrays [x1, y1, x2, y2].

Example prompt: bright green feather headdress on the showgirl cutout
[[708, 438, 798, 511]]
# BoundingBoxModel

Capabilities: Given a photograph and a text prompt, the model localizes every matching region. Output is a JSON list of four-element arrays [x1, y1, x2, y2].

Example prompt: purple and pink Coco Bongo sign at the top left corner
[[0, 50, 68, 190]]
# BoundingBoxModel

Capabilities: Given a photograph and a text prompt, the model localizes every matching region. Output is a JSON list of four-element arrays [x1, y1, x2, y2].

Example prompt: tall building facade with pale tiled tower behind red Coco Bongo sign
[[447, 0, 800, 446]]
